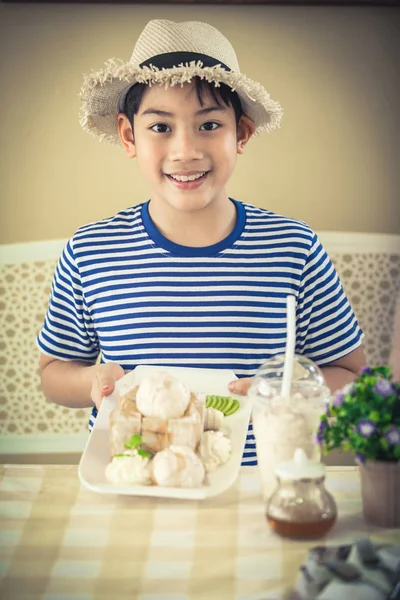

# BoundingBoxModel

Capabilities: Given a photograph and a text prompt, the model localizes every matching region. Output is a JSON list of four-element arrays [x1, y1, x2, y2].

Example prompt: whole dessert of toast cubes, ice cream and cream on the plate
[[105, 370, 234, 488]]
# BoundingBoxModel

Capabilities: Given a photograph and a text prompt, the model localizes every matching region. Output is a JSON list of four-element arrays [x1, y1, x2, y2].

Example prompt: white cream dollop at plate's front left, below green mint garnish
[[106, 450, 152, 485]]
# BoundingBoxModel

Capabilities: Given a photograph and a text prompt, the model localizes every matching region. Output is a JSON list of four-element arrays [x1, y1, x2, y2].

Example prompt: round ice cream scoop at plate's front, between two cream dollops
[[152, 446, 205, 488]]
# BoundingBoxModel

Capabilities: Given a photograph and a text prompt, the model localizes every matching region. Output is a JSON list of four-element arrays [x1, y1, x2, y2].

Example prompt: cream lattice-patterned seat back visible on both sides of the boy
[[0, 251, 400, 436]]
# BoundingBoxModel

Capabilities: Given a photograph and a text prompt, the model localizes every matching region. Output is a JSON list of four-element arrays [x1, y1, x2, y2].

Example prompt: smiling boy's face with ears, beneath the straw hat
[[118, 84, 255, 212]]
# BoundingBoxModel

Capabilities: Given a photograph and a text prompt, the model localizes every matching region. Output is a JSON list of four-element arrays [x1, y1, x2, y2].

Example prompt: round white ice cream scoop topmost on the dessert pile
[[136, 371, 190, 420]]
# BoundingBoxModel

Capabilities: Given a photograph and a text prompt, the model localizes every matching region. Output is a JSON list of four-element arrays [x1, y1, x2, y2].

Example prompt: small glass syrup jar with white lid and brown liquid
[[266, 448, 337, 540]]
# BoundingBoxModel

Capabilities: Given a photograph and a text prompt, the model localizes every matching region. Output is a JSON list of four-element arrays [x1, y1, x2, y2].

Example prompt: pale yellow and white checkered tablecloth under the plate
[[0, 465, 399, 600]]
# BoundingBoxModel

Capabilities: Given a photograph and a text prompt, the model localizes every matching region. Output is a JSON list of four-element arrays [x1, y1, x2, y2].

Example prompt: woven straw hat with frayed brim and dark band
[[80, 20, 283, 144]]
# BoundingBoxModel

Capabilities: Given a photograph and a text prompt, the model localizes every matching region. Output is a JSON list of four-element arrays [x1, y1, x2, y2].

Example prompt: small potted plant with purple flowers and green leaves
[[317, 366, 400, 527]]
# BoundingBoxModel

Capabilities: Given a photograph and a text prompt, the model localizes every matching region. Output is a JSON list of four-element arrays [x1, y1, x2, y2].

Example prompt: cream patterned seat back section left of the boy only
[[0, 261, 89, 435]]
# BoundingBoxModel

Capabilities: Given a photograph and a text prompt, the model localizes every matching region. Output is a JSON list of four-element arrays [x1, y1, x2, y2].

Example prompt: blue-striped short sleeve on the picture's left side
[[37, 240, 99, 363]]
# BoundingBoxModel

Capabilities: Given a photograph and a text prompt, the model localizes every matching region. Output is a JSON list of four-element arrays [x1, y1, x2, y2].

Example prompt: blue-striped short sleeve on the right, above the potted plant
[[296, 234, 363, 366]]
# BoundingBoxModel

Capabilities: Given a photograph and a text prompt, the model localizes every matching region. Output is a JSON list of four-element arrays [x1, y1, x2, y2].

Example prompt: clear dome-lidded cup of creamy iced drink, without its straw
[[248, 354, 330, 500]]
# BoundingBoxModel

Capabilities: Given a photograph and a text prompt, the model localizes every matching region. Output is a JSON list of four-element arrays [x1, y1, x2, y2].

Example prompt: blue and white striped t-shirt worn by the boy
[[38, 200, 362, 465]]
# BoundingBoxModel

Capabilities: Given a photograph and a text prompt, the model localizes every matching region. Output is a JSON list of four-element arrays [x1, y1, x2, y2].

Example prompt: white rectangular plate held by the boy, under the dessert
[[79, 365, 251, 500]]
